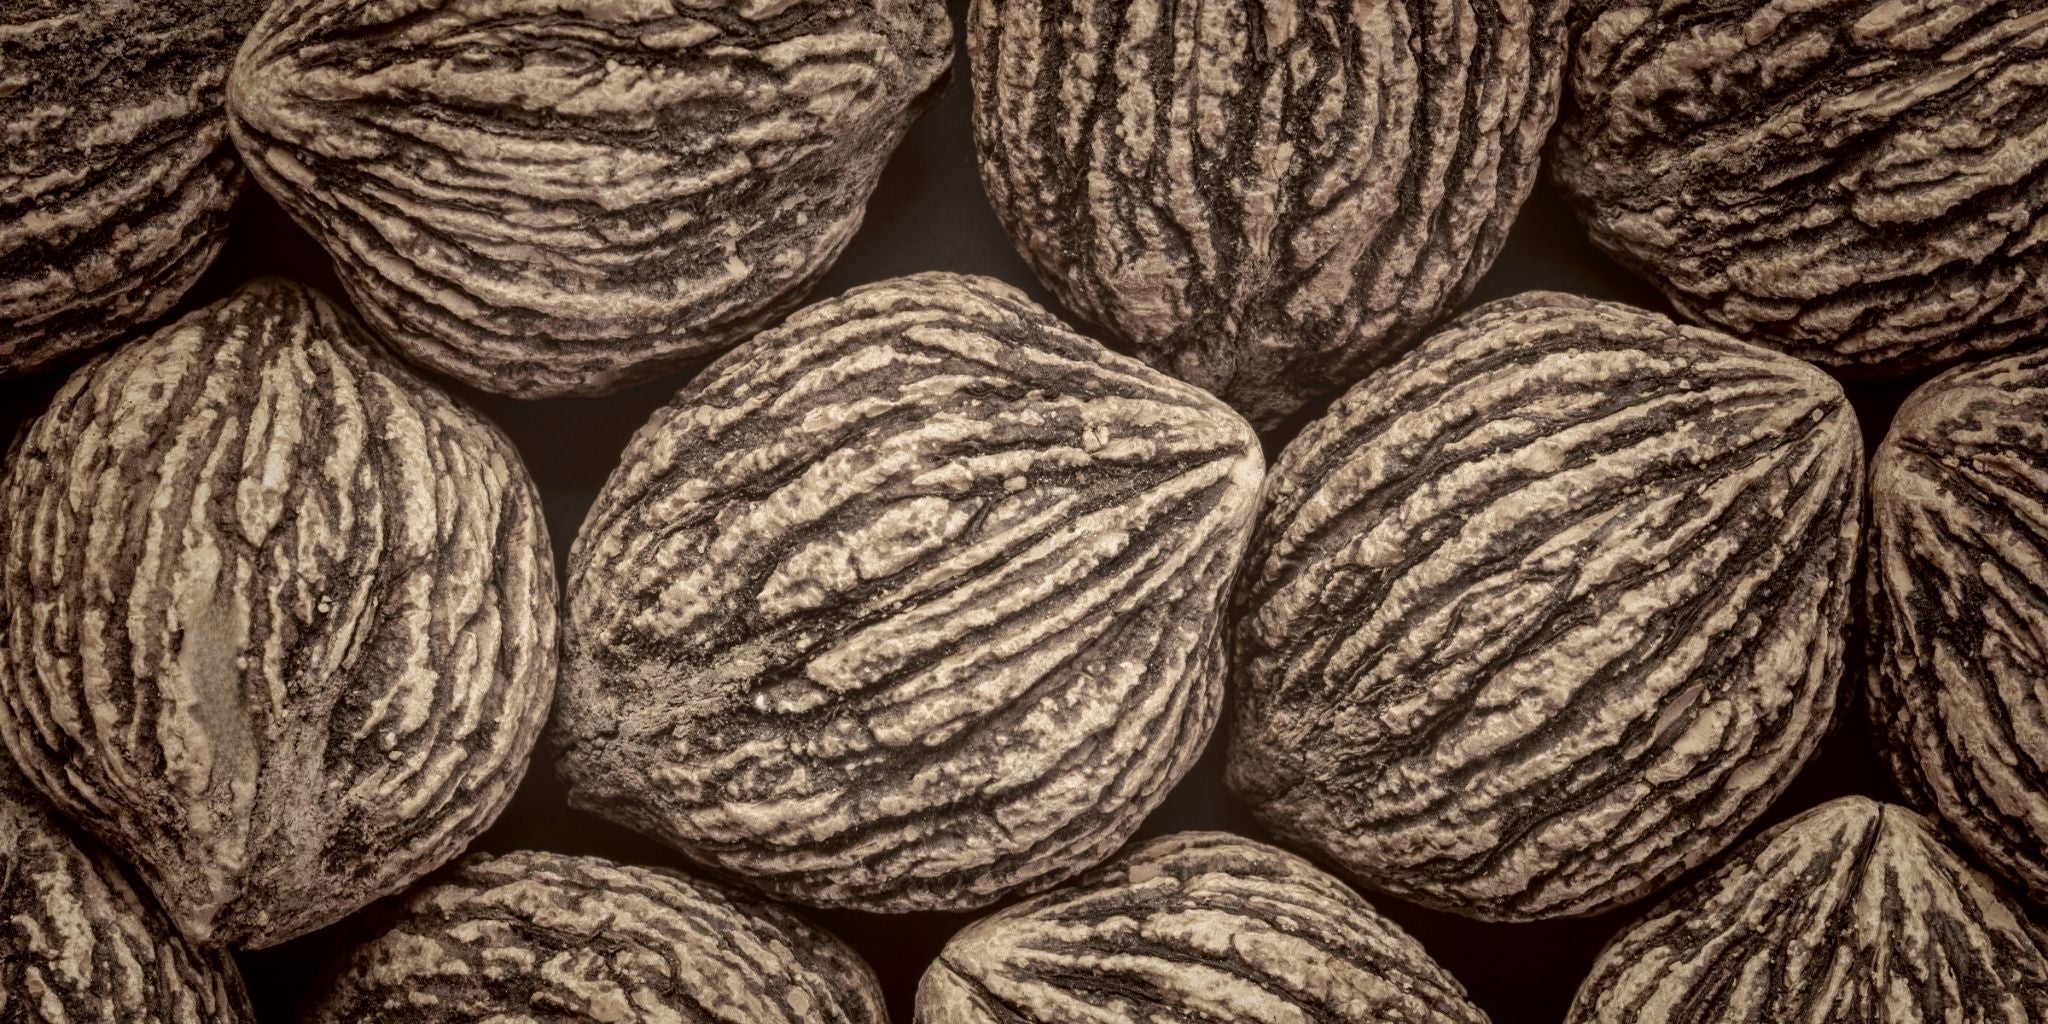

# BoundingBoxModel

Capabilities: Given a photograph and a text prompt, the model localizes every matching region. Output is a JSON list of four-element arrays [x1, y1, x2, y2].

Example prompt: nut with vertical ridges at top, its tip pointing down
[[969, 0, 1569, 428]]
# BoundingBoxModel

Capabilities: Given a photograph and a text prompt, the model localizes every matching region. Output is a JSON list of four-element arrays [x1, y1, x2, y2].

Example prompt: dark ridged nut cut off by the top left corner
[[0, 0, 262, 377]]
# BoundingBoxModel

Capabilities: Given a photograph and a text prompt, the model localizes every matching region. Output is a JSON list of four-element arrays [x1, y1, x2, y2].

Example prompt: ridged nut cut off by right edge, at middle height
[[1868, 352, 2048, 907]]
